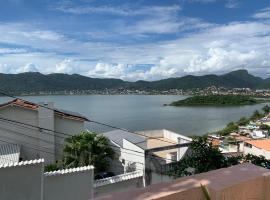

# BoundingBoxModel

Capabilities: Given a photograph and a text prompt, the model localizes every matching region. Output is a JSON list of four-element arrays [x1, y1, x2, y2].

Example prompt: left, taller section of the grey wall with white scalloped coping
[[0, 161, 43, 200]]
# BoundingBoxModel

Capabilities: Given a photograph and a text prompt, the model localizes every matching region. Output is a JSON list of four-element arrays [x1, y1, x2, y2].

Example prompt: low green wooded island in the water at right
[[170, 95, 262, 106]]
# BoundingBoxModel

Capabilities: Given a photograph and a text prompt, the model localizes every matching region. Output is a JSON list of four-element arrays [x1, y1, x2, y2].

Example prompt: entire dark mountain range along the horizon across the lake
[[0, 70, 270, 94]]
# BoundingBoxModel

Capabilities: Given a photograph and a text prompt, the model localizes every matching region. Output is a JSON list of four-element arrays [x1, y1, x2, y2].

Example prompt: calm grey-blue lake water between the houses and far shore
[[0, 95, 264, 135]]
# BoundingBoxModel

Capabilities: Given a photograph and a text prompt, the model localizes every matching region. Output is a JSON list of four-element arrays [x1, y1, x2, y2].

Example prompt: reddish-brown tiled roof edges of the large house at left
[[0, 99, 88, 121]]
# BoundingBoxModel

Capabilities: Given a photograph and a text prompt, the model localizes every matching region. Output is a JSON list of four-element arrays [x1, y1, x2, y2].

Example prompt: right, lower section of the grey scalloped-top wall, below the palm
[[44, 167, 94, 200]]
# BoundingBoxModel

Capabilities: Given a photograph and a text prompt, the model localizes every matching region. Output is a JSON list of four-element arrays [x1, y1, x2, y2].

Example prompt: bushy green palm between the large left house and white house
[[63, 132, 114, 172]]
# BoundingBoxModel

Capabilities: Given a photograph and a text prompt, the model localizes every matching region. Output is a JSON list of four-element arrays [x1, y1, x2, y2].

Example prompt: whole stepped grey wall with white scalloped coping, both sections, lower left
[[0, 159, 94, 200]]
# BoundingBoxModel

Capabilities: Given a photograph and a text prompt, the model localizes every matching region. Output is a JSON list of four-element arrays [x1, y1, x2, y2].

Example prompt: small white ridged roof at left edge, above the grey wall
[[0, 144, 20, 165]]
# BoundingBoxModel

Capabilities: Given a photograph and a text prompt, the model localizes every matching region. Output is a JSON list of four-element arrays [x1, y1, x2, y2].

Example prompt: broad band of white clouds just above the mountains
[[0, 8, 270, 80]]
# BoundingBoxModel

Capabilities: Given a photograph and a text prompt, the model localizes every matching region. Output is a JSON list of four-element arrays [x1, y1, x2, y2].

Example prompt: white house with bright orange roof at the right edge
[[244, 139, 270, 159]]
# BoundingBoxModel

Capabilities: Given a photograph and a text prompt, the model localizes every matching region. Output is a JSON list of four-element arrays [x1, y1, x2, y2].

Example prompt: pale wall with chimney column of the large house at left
[[0, 105, 84, 163]]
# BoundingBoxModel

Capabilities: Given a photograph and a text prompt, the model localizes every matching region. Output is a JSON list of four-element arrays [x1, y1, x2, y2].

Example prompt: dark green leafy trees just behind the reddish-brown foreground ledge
[[168, 136, 270, 177]]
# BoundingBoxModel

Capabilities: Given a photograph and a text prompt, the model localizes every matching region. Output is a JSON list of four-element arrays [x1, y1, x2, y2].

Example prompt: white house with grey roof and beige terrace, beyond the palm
[[103, 129, 192, 178]]
